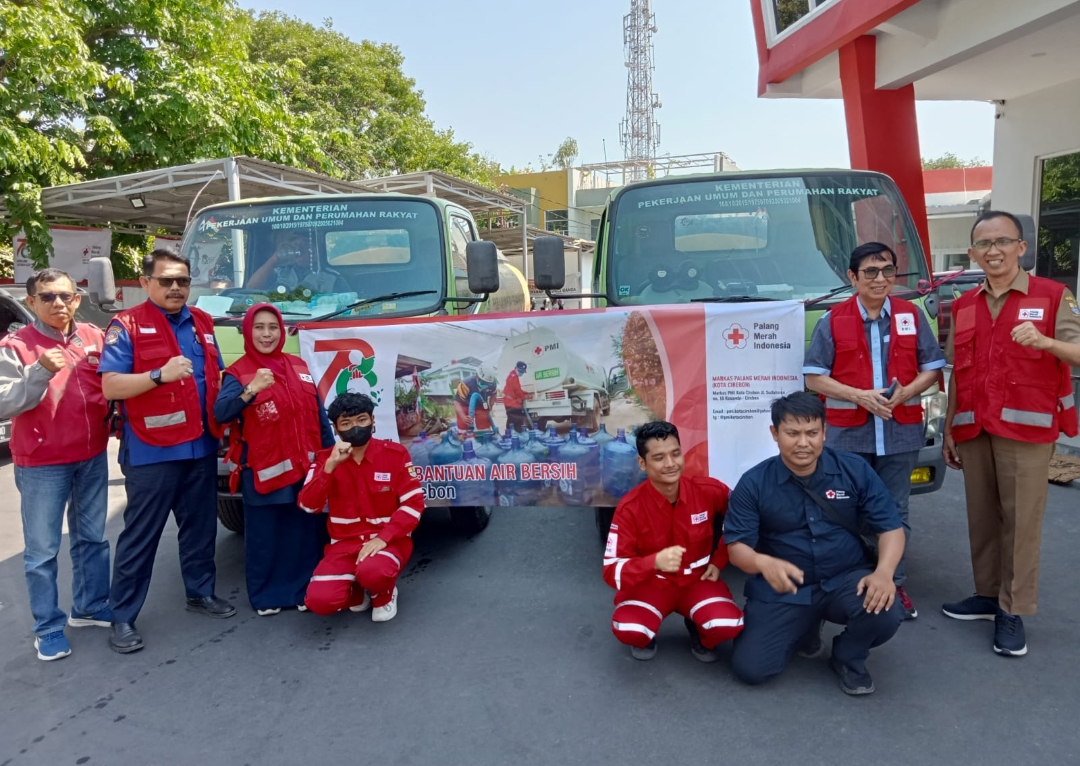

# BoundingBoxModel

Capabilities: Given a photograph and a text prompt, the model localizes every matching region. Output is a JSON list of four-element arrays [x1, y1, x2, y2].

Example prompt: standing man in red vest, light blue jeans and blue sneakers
[[0, 269, 112, 661]]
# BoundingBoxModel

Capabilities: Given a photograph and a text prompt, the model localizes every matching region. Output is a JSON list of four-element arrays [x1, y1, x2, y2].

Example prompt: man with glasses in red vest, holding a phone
[[802, 242, 945, 620]]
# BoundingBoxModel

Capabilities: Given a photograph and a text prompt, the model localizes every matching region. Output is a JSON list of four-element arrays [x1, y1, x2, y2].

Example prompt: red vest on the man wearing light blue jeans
[[3, 323, 109, 467]]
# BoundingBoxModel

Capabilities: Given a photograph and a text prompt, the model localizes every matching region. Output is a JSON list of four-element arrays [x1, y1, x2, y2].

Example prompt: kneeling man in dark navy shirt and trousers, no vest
[[724, 392, 904, 695]]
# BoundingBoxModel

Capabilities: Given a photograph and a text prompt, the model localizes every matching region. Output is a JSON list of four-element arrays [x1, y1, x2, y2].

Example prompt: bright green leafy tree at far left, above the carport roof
[[0, 0, 326, 266]]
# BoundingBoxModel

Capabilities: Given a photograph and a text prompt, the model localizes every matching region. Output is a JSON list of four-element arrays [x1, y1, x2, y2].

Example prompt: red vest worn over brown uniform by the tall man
[[953, 277, 1077, 444]]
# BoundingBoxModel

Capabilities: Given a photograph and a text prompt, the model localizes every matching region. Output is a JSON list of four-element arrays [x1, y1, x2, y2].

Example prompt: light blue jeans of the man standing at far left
[[15, 452, 109, 636]]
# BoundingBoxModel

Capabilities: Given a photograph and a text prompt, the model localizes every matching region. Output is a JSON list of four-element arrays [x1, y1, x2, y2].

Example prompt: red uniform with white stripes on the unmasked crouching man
[[604, 475, 743, 649]]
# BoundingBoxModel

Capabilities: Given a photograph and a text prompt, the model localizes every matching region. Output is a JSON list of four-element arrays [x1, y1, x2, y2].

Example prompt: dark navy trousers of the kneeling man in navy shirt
[[731, 569, 904, 684]]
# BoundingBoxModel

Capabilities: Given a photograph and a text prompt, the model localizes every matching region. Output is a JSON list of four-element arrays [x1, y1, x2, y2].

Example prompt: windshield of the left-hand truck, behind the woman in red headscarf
[[181, 197, 445, 321]]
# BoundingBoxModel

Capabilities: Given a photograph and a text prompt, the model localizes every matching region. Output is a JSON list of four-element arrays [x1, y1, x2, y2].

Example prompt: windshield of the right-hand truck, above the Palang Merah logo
[[605, 173, 928, 305]]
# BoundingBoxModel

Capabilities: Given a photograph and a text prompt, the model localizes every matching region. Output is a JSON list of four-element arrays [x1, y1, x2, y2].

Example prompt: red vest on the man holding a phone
[[823, 296, 922, 428]]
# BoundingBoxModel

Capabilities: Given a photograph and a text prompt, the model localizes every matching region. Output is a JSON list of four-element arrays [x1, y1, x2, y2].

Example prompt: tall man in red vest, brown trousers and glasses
[[942, 211, 1080, 657]]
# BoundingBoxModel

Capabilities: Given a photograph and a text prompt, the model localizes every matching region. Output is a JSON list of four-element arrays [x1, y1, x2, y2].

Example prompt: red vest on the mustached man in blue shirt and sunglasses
[[116, 300, 222, 447]]
